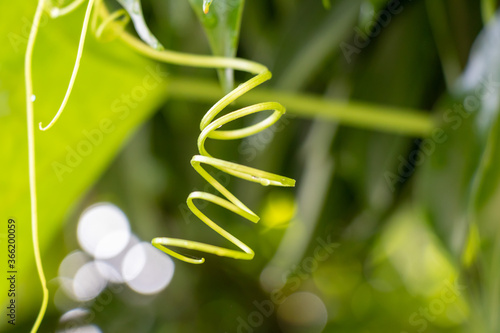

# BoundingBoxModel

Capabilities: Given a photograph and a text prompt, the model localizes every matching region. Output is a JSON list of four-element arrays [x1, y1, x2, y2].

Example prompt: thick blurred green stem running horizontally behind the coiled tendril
[[167, 77, 435, 137]]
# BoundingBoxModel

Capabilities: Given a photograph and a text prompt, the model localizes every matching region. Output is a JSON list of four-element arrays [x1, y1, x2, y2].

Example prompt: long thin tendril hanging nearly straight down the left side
[[24, 0, 49, 333]]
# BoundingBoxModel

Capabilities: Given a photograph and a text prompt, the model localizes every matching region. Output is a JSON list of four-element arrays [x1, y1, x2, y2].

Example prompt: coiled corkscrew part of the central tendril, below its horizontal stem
[[152, 94, 295, 264]]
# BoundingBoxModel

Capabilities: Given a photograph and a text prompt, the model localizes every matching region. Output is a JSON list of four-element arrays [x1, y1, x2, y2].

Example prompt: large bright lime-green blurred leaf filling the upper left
[[0, 1, 165, 331]]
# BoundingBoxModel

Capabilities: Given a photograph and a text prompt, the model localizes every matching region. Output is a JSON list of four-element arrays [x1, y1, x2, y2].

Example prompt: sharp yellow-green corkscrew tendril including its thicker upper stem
[[95, 1, 295, 264]]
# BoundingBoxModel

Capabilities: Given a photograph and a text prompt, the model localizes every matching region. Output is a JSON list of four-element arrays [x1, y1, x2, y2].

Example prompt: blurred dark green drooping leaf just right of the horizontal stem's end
[[414, 96, 481, 258]]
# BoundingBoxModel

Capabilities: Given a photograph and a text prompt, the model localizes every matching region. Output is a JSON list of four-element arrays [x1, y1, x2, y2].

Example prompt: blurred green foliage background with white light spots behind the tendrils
[[0, 0, 500, 333]]
